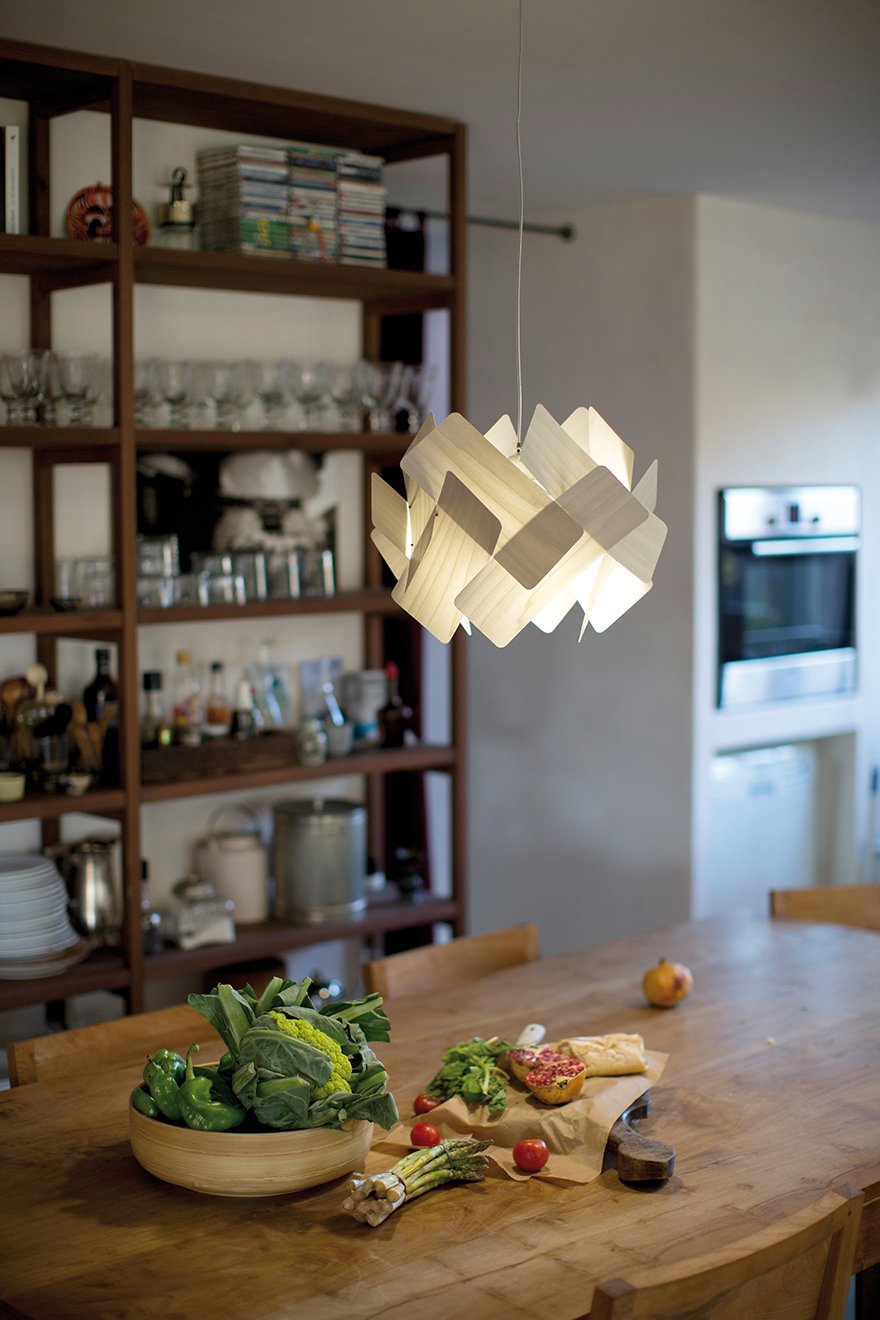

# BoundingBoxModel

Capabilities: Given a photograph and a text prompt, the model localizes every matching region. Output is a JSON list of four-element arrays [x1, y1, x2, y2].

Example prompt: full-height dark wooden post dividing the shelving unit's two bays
[[111, 62, 144, 1012]]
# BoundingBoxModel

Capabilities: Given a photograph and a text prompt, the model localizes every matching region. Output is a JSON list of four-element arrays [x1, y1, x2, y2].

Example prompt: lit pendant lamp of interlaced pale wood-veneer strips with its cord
[[372, 0, 666, 647]]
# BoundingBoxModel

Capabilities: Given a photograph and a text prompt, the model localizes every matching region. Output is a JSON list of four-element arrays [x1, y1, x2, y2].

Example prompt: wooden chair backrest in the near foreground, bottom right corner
[[590, 1188, 864, 1320]]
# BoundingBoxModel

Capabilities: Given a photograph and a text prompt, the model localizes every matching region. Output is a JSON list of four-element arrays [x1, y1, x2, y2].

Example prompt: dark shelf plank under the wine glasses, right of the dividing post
[[135, 428, 413, 461]]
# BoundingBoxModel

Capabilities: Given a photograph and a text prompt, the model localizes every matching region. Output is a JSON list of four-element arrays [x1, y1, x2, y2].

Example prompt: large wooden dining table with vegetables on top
[[0, 915, 880, 1320]]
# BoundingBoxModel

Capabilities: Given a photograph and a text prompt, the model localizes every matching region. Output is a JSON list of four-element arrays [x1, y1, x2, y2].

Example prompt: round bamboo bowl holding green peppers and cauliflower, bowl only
[[128, 1104, 373, 1196]]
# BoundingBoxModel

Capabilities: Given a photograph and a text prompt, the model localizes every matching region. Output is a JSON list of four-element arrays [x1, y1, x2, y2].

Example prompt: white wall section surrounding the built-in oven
[[694, 198, 880, 902]]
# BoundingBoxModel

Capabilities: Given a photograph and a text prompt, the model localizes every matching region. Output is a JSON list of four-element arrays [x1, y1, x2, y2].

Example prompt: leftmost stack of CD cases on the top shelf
[[197, 147, 293, 256]]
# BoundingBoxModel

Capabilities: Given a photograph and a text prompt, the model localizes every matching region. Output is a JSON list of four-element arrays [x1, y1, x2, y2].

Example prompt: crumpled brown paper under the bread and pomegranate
[[373, 1049, 669, 1183]]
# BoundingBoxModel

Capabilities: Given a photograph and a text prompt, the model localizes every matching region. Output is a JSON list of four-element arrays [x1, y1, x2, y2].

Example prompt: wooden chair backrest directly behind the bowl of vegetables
[[7, 1003, 226, 1086]]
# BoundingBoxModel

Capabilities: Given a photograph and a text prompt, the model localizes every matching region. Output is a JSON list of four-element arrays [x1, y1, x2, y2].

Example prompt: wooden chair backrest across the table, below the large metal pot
[[361, 923, 540, 999]]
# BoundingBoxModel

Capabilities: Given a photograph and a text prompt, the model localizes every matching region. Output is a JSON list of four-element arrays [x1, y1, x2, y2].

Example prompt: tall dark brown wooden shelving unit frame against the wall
[[0, 42, 466, 1011]]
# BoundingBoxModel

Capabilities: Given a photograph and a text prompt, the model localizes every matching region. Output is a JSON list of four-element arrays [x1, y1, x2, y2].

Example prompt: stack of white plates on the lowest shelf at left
[[0, 853, 90, 981]]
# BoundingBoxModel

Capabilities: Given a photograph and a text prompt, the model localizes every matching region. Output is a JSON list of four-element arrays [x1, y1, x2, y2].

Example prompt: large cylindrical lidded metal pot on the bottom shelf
[[272, 797, 367, 925]]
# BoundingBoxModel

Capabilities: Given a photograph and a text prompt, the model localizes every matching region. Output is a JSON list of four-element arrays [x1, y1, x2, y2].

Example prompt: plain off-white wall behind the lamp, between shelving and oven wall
[[468, 199, 694, 953]]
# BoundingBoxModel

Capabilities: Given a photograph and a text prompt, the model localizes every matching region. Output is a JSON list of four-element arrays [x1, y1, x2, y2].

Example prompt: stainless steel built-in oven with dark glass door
[[718, 486, 859, 706]]
